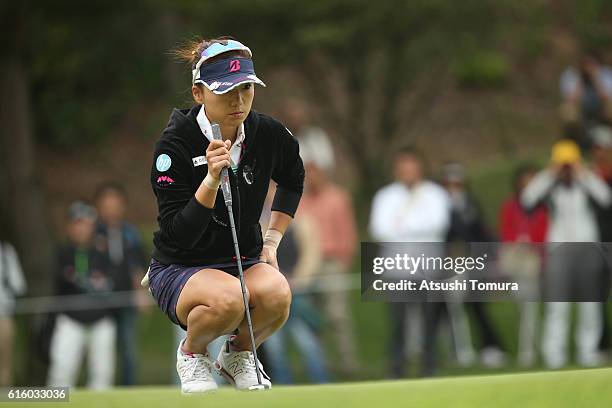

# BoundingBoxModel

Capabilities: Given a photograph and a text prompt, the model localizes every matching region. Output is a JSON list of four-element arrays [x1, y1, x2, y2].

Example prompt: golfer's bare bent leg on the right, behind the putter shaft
[[232, 263, 291, 350]]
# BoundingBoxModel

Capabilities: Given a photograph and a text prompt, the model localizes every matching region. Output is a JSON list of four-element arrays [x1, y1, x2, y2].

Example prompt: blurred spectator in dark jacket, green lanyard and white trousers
[[48, 201, 116, 389]]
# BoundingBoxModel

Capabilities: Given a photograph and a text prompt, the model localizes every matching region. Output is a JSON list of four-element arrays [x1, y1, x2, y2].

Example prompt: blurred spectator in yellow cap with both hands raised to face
[[521, 140, 611, 368]]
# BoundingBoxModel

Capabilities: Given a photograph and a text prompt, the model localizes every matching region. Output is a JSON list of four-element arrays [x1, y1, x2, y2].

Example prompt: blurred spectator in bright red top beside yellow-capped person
[[499, 165, 548, 366]]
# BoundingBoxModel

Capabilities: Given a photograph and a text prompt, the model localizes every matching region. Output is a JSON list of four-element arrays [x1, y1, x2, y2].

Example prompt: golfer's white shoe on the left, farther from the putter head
[[176, 340, 218, 394]]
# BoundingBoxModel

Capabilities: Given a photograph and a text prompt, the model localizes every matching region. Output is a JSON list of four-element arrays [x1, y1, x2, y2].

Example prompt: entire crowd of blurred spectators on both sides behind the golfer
[[0, 53, 612, 389]]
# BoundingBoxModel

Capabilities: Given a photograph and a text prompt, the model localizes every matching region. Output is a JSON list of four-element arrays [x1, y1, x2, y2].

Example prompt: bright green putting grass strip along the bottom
[[15, 368, 612, 408]]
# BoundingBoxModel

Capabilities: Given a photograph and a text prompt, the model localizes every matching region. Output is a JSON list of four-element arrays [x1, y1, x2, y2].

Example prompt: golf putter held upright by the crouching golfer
[[211, 123, 265, 391]]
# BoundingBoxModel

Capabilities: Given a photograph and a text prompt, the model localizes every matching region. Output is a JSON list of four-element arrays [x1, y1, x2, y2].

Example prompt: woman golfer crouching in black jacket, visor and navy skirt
[[148, 38, 304, 393]]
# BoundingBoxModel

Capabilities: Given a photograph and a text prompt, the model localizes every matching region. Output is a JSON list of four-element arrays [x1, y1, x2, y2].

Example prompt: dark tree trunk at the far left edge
[[0, 2, 54, 295]]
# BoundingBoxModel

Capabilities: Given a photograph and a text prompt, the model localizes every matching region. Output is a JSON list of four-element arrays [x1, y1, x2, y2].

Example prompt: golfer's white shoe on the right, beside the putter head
[[215, 342, 272, 391]]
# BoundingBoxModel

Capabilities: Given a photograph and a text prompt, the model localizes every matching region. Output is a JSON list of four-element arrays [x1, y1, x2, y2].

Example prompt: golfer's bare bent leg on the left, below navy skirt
[[176, 269, 244, 354]]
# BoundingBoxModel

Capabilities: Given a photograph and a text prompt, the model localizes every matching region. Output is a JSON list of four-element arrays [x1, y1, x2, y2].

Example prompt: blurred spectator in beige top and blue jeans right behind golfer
[[262, 186, 329, 384]]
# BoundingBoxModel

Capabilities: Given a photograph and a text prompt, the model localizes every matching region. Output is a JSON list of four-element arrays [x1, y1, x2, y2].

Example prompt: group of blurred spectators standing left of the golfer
[[0, 183, 150, 389]]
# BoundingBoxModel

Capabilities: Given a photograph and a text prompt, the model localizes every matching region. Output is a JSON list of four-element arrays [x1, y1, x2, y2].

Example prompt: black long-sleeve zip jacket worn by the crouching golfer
[[151, 105, 304, 266]]
